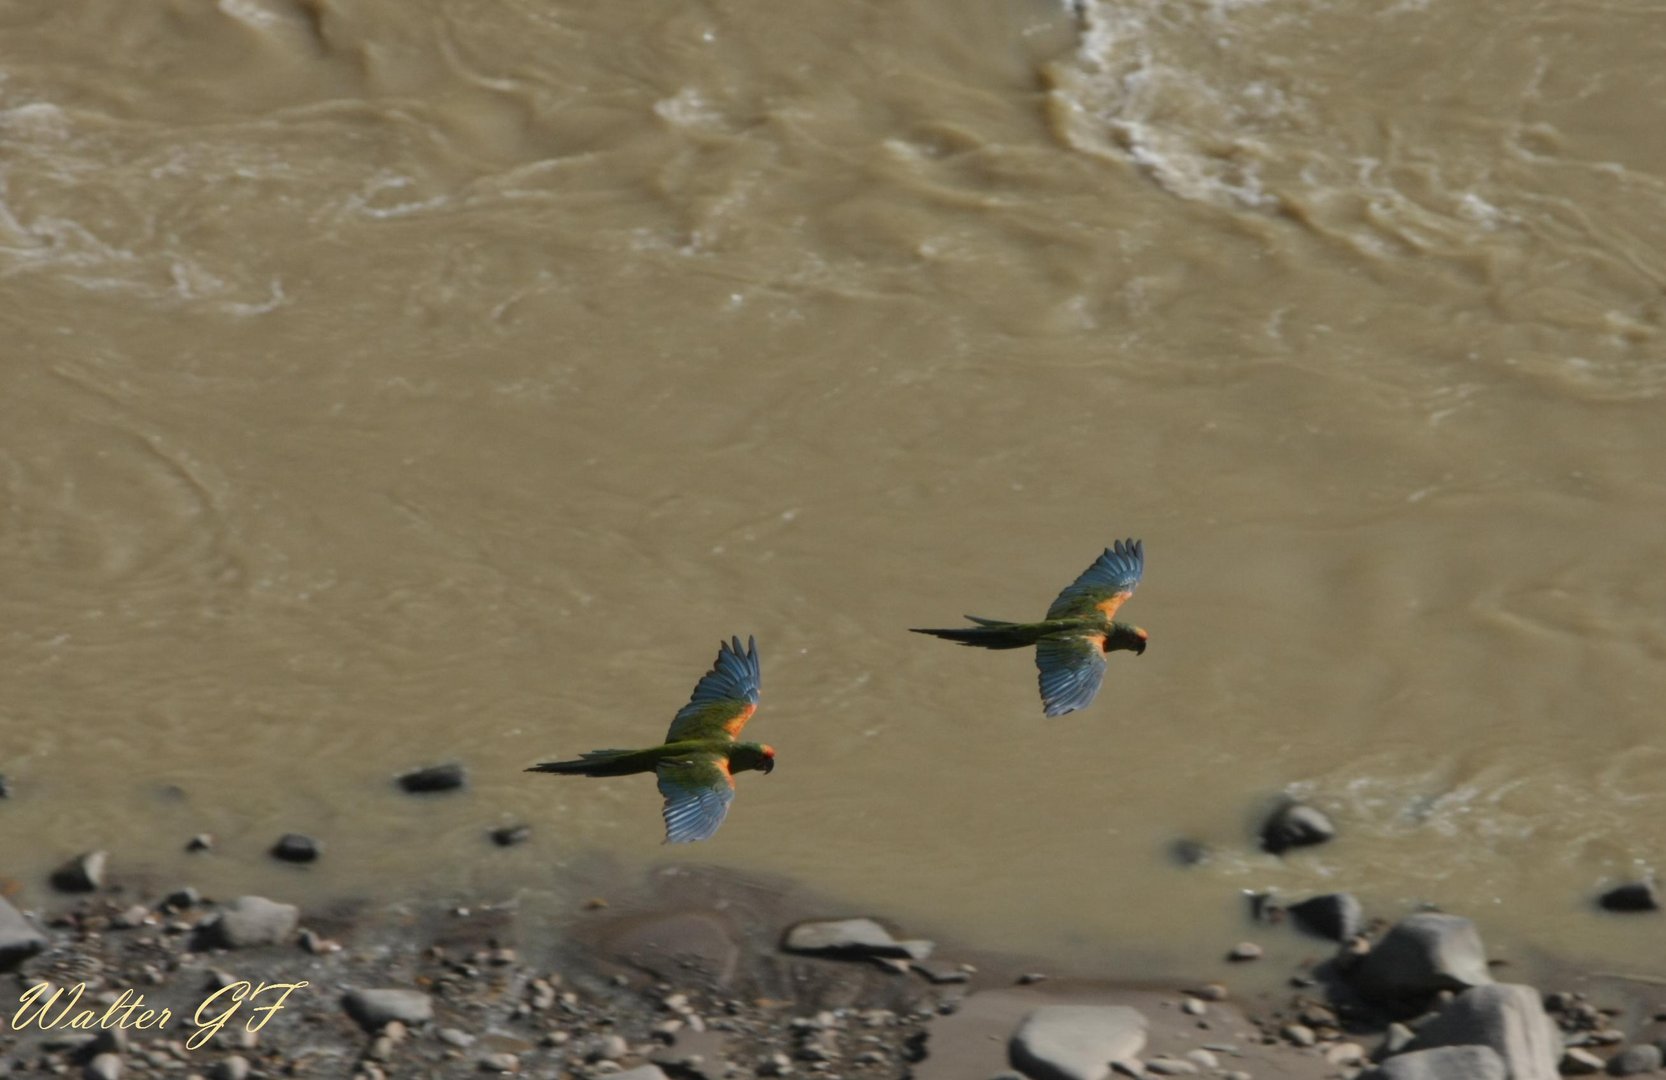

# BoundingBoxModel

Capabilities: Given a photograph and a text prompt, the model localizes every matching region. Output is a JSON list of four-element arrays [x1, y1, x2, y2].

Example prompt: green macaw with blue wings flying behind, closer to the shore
[[526, 637, 775, 843]]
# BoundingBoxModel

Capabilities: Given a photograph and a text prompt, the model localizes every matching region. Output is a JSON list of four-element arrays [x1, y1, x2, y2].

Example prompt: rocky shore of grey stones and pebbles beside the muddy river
[[0, 846, 1666, 1080]]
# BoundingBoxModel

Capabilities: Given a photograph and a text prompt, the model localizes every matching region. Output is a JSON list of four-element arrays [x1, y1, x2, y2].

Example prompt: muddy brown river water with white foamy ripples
[[0, 0, 1666, 973]]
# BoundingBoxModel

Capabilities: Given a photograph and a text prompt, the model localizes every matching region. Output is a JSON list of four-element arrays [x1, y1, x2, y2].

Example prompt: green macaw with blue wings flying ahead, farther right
[[915, 540, 1148, 717]]
